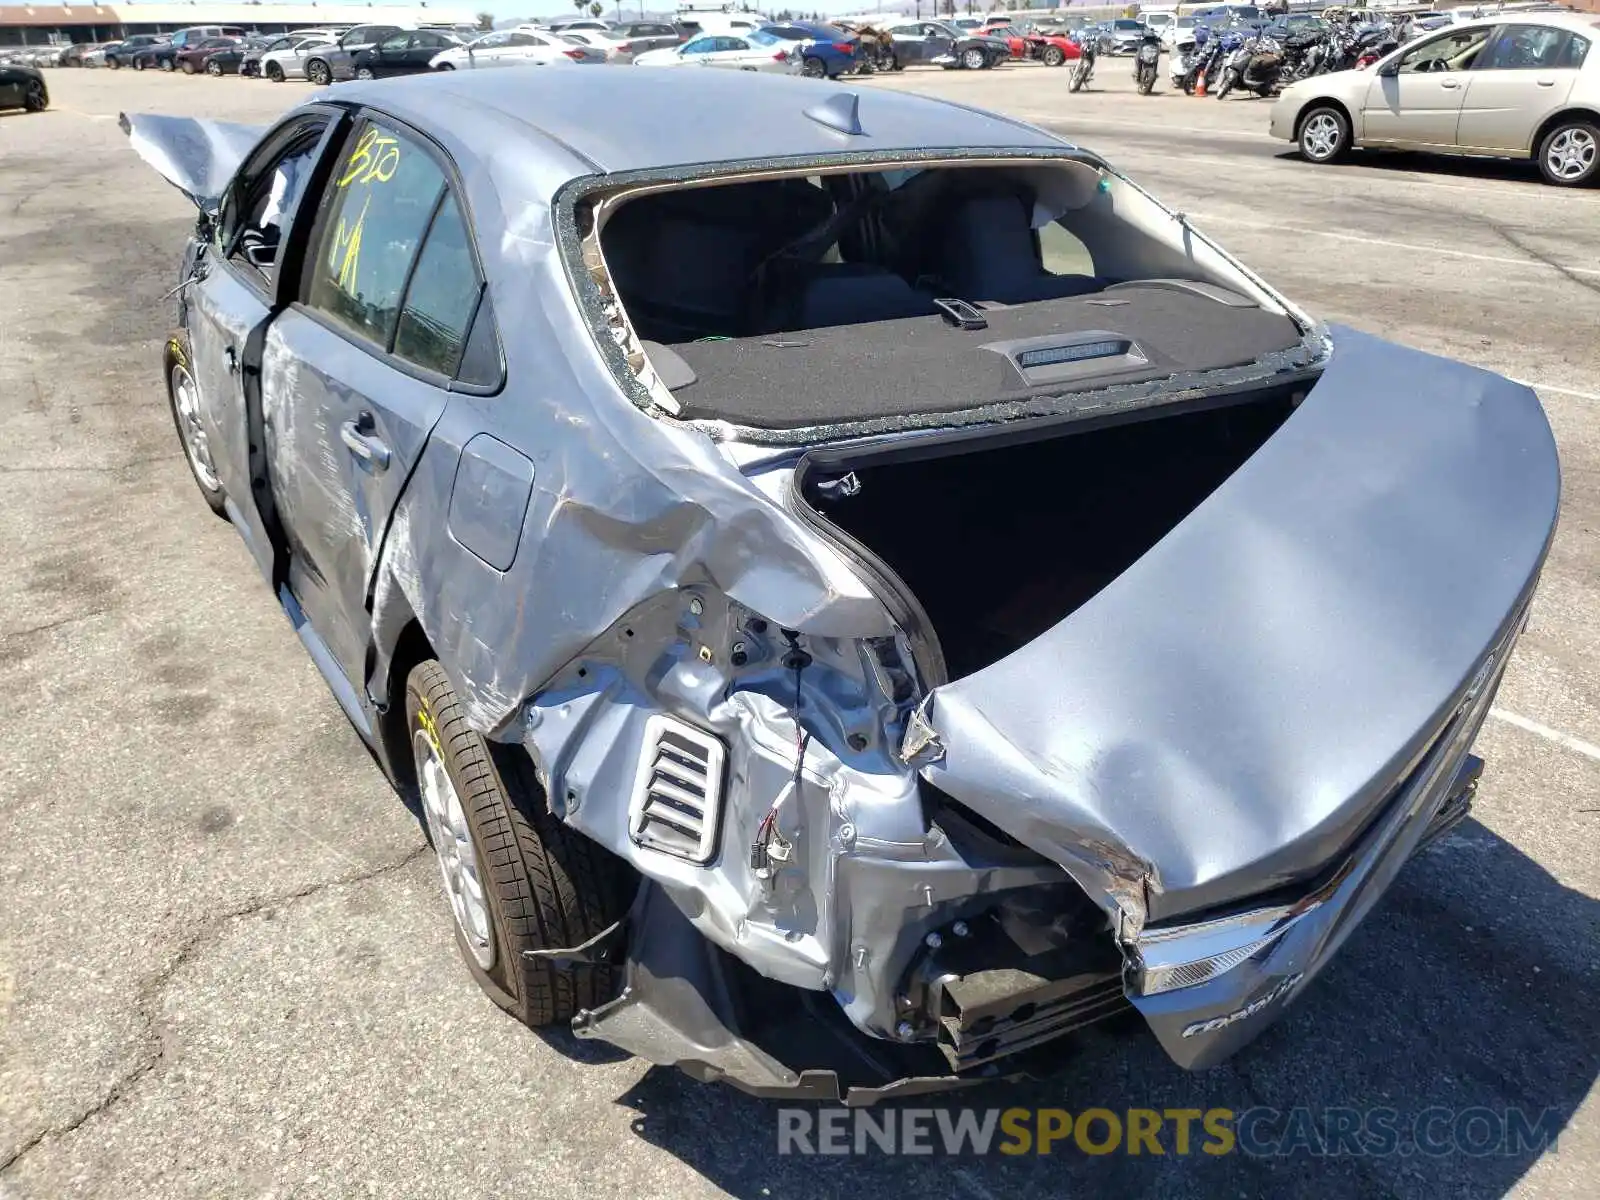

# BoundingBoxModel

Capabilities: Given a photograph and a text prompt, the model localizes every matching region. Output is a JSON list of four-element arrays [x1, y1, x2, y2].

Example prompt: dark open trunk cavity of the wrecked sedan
[[798, 386, 1304, 678]]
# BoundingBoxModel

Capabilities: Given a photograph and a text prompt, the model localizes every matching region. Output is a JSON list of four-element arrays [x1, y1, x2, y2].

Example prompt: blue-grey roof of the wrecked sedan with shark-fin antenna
[[338, 60, 1069, 178]]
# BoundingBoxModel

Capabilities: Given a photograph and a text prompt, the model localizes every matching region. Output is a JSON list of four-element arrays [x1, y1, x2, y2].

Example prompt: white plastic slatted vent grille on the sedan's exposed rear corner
[[627, 714, 725, 862]]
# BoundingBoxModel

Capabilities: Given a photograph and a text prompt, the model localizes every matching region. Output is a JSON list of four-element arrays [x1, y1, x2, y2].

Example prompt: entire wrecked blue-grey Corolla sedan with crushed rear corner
[[123, 72, 1560, 1104]]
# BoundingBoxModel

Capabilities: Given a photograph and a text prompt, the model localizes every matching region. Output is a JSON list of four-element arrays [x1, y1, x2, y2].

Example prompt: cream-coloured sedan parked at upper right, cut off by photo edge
[[1270, 11, 1600, 187]]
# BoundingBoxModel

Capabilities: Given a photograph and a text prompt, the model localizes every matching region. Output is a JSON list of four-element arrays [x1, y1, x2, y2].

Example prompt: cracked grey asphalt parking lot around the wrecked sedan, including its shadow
[[0, 61, 1600, 1200]]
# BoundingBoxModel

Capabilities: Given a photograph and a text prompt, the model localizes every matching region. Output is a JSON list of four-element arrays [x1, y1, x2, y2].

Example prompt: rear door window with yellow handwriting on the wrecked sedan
[[306, 125, 445, 349]]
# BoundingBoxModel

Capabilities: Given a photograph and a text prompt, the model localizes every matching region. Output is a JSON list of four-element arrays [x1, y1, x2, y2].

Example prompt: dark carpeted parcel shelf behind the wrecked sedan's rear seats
[[674, 283, 1301, 429]]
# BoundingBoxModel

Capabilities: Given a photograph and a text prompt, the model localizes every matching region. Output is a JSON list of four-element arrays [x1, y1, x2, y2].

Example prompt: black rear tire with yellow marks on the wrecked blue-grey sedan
[[405, 659, 637, 1029]]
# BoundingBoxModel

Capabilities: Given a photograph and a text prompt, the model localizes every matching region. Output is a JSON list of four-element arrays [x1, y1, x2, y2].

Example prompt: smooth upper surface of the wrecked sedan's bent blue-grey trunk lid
[[923, 330, 1560, 928]]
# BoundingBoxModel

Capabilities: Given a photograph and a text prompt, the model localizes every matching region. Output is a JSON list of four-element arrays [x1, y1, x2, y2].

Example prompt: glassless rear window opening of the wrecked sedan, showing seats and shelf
[[586, 158, 1302, 429]]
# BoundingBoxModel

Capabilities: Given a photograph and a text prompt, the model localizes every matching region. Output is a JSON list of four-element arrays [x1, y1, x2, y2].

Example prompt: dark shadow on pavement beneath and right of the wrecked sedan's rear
[[618, 821, 1600, 1200]]
